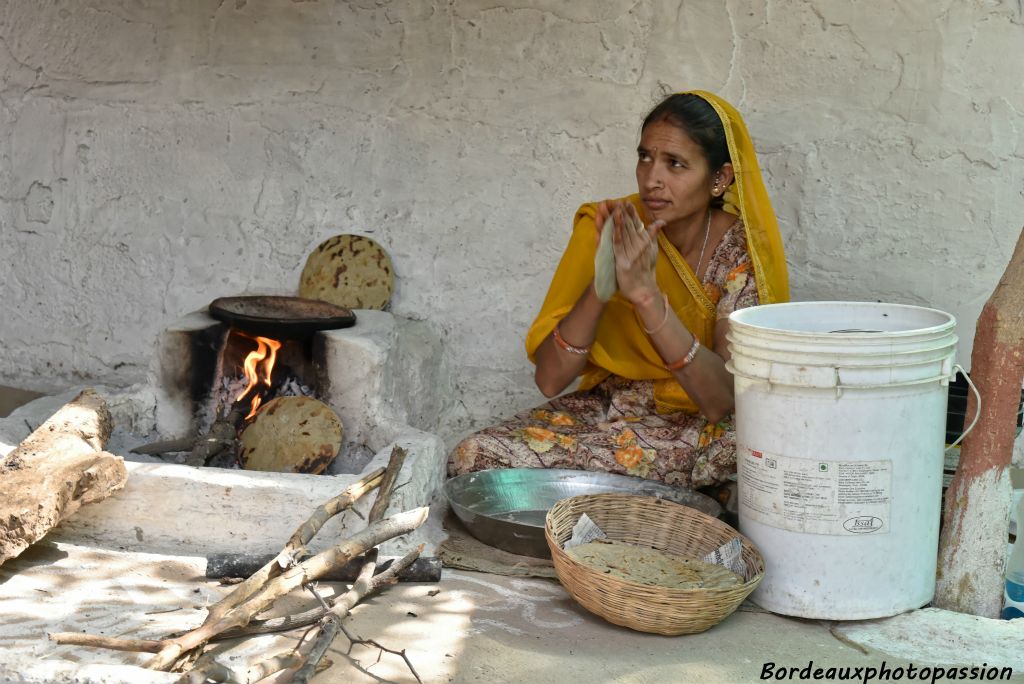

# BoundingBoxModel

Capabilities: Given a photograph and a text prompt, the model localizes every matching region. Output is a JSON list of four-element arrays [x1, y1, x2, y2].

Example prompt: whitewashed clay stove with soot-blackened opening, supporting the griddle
[[154, 301, 452, 473]]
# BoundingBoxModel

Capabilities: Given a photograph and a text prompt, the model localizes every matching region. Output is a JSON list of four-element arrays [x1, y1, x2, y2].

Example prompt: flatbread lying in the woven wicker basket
[[565, 540, 743, 589]]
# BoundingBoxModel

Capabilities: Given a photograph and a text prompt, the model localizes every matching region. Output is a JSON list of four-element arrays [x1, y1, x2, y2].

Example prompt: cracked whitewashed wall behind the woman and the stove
[[0, 0, 1024, 432]]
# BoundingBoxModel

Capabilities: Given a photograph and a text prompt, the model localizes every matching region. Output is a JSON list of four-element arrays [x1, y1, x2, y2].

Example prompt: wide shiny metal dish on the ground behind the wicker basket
[[444, 468, 722, 558]]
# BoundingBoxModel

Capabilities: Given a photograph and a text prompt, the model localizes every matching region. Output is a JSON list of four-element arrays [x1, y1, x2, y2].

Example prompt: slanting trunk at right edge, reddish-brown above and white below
[[933, 231, 1024, 617]]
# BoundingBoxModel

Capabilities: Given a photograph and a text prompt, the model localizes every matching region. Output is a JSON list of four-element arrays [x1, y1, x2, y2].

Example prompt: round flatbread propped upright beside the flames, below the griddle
[[239, 396, 344, 473]]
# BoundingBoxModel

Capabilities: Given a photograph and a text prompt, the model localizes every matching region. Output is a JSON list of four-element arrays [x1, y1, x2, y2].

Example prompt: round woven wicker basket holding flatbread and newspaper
[[544, 494, 765, 636]]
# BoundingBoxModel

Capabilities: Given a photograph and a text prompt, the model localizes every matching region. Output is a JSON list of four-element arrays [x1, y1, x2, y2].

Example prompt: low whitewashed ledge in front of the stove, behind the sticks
[[46, 428, 445, 556]]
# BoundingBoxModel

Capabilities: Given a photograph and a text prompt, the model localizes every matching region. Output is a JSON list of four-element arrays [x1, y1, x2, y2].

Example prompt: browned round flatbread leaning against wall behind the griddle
[[299, 234, 394, 310]]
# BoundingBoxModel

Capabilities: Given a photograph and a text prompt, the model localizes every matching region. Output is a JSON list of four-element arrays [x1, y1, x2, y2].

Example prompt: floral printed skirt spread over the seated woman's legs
[[449, 376, 736, 487]]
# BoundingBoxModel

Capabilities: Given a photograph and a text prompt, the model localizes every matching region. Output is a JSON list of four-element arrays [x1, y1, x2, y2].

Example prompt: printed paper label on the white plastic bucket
[[736, 445, 892, 536]]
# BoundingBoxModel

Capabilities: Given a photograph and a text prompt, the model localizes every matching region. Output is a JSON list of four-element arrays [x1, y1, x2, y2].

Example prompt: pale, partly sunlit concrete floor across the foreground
[[0, 385, 1024, 684]]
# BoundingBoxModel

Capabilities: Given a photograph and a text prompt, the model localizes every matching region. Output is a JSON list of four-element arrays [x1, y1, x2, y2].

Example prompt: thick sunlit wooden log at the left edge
[[0, 389, 128, 563]]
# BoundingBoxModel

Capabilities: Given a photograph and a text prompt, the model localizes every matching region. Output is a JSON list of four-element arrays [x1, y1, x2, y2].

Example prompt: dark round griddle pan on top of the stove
[[210, 295, 355, 339]]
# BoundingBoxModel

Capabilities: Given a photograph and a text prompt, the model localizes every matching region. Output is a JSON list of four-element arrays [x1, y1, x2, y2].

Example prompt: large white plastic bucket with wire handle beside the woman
[[728, 302, 956, 619]]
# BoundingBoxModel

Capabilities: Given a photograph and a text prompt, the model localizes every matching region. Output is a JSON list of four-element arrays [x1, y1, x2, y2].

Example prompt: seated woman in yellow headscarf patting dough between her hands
[[449, 91, 788, 487]]
